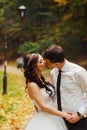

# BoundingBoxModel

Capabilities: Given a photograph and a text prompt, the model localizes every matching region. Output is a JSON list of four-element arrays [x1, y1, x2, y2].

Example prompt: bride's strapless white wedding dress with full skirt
[[25, 89, 68, 130]]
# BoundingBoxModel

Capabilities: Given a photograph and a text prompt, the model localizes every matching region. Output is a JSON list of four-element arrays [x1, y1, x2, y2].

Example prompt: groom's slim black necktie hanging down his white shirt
[[57, 70, 62, 111]]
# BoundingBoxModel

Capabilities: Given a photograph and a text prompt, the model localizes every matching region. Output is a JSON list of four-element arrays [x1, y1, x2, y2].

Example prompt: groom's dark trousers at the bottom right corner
[[65, 118, 87, 130]]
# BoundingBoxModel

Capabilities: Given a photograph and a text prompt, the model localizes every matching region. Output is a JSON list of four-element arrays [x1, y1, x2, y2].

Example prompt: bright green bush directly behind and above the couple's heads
[[18, 37, 53, 55]]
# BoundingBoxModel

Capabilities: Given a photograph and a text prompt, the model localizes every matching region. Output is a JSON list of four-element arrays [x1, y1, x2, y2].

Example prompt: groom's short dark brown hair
[[42, 45, 64, 63]]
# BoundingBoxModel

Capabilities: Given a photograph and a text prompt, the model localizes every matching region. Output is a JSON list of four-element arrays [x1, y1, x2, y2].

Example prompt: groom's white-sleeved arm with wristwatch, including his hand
[[68, 70, 87, 123]]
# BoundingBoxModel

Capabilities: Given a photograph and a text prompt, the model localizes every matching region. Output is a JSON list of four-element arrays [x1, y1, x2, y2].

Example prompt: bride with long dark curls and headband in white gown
[[23, 53, 69, 130]]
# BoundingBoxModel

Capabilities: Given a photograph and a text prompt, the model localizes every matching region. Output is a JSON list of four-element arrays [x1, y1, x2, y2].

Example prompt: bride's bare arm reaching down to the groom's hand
[[28, 82, 69, 118]]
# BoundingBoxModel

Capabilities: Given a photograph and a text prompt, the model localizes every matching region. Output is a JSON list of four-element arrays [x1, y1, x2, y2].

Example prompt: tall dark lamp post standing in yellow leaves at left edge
[[3, 36, 7, 94]]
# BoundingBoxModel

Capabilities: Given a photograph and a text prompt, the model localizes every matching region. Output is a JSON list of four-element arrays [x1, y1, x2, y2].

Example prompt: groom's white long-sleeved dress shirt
[[51, 60, 87, 117]]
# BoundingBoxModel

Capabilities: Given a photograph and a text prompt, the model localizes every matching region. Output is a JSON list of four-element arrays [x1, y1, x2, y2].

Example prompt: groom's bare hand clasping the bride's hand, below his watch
[[66, 112, 81, 124]]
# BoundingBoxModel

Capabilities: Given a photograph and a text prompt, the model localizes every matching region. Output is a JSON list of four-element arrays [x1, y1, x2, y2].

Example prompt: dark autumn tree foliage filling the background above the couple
[[0, 0, 87, 57]]
